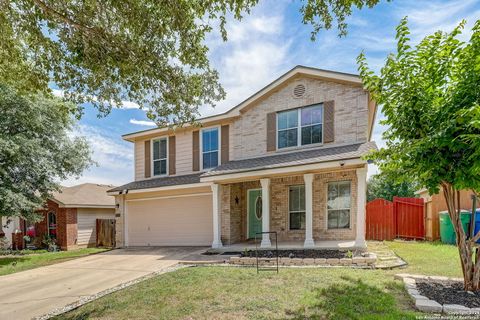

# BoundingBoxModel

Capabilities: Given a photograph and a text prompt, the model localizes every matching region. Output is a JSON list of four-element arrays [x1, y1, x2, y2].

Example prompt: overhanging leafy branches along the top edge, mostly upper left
[[0, 0, 379, 125]]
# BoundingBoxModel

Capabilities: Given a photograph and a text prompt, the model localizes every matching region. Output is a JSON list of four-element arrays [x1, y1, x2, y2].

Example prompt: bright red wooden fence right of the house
[[365, 197, 425, 240]]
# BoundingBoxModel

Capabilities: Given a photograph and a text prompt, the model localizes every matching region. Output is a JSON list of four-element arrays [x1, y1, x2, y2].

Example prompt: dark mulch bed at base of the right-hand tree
[[416, 280, 480, 308]]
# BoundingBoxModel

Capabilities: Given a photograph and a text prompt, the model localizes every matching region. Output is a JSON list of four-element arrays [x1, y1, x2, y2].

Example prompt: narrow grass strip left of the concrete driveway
[[0, 248, 106, 276]]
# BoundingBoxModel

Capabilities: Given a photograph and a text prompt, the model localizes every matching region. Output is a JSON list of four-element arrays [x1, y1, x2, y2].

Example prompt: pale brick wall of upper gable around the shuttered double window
[[230, 78, 368, 160]]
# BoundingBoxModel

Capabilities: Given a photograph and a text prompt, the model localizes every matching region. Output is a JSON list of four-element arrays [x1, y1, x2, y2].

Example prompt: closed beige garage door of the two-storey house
[[127, 195, 213, 246]]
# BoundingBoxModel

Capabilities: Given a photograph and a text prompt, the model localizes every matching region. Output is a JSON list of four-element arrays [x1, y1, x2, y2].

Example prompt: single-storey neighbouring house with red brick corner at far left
[[22, 183, 115, 250]]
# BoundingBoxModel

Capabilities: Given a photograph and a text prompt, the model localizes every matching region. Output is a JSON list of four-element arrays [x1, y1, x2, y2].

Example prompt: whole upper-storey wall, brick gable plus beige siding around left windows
[[129, 77, 369, 181]]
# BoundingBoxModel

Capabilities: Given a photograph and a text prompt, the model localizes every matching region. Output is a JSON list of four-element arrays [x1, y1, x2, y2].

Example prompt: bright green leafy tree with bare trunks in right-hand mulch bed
[[358, 19, 480, 291]]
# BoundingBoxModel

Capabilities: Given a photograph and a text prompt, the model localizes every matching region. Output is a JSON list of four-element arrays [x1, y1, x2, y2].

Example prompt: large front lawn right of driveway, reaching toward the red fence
[[53, 241, 461, 320]]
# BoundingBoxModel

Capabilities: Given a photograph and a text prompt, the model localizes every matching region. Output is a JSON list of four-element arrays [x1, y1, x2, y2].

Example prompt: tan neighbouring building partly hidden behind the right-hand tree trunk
[[415, 187, 480, 240]]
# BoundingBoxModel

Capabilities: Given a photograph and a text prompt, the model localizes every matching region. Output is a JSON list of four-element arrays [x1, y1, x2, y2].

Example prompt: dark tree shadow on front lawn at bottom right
[[286, 276, 415, 320]]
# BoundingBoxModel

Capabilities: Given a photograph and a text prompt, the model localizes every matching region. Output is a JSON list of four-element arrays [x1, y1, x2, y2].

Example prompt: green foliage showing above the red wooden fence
[[367, 173, 419, 201]]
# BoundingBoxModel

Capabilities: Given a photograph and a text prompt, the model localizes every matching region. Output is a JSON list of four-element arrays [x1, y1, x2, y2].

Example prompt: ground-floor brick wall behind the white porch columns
[[221, 170, 357, 245]]
